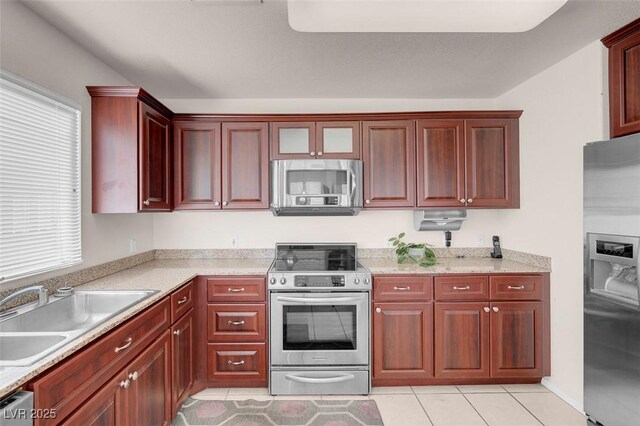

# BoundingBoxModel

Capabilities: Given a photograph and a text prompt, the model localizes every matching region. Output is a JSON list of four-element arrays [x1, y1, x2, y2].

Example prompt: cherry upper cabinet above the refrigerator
[[602, 19, 640, 137]]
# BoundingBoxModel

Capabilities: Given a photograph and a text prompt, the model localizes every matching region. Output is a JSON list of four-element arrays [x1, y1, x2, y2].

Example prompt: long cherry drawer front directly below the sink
[[30, 297, 171, 425]]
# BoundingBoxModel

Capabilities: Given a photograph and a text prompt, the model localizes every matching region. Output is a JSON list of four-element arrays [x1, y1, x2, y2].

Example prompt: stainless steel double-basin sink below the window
[[0, 290, 158, 367]]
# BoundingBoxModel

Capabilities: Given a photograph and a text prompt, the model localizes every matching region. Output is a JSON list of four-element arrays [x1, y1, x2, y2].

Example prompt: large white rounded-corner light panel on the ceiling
[[287, 0, 567, 33]]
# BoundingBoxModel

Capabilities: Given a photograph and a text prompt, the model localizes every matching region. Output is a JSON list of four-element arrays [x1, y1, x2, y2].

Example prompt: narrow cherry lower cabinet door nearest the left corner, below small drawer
[[171, 310, 194, 417]]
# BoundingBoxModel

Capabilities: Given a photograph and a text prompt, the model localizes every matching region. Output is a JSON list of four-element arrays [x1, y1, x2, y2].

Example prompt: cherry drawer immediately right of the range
[[373, 276, 432, 302]]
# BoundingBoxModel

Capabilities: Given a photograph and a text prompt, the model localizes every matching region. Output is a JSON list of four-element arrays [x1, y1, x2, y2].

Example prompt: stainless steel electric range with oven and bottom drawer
[[268, 244, 371, 395]]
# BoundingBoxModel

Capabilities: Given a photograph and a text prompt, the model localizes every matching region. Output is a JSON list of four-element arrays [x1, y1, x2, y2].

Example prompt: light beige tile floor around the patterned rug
[[193, 384, 586, 426]]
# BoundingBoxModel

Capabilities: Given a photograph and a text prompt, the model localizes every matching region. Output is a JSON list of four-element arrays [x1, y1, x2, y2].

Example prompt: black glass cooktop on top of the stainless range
[[272, 244, 358, 272]]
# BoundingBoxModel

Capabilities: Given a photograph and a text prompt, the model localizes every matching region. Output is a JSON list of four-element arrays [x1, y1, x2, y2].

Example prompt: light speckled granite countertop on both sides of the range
[[0, 253, 549, 397]]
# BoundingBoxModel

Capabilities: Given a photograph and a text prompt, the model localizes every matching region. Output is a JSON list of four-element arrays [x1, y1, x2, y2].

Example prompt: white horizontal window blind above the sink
[[0, 71, 82, 282]]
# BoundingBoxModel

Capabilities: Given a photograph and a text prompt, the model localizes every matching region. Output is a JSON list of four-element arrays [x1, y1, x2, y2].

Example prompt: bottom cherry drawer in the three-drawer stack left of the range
[[207, 343, 267, 381]]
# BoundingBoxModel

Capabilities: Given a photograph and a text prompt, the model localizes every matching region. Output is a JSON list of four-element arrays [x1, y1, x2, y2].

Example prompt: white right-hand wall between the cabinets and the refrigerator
[[497, 41, 608, 407]]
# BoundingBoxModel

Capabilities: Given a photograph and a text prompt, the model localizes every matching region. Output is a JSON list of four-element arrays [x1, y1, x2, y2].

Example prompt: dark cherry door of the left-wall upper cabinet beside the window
[[138, 102, 171, 211]]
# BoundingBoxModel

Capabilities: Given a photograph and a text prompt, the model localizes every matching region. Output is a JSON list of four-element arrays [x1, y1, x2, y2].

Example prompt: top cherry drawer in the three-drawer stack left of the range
[[207, 277, 267, 303]]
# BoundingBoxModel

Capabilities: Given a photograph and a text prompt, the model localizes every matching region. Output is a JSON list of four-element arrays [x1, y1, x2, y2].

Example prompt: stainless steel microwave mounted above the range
[[271, 160, 362, 216]]
